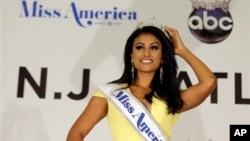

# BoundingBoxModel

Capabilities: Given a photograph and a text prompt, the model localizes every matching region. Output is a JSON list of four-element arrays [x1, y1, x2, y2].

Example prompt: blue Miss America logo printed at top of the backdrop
[[20, 0, 137, 28]]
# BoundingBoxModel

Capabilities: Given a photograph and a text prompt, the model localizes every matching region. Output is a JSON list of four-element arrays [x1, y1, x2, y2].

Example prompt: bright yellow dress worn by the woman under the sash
[[94, 85, 179, 141]]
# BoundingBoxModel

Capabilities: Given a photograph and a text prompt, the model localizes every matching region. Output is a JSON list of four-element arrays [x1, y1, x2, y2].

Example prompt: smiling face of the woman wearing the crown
[[131, 33, 162, 73]]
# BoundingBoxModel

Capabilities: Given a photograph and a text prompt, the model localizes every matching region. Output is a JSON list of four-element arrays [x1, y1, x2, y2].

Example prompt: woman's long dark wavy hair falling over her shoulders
[[111, 26, 183, 114]]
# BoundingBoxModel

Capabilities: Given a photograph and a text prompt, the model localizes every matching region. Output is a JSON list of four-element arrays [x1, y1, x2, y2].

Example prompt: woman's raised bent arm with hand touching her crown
[[165, 26, 217, 112]]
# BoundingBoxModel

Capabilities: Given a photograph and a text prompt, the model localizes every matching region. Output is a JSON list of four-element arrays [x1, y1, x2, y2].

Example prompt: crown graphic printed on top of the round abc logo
[[191, 0, 230, 11]]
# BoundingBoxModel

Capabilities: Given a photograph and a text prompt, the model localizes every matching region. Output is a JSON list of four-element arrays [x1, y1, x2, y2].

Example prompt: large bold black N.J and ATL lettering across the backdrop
[[17, 67, 250, 104]]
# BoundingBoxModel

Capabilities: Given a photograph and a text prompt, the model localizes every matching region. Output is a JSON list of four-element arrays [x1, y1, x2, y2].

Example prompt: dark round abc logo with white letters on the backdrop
[[188, 8, 233, 43]]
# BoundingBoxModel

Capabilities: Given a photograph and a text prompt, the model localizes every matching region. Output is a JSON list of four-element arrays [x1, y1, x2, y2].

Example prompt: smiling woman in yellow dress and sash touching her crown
[[67, 26, 216, 141]]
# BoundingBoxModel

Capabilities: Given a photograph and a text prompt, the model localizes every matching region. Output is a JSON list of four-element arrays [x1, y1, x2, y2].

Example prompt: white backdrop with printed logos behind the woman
[[0, 0, 250, 141]]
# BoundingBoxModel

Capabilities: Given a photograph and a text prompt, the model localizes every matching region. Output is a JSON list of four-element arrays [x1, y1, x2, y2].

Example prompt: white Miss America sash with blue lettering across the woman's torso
[[98, 84, 167, 141]]
